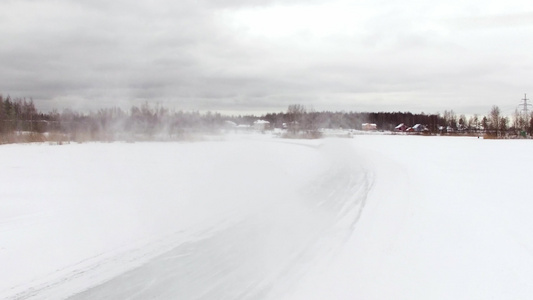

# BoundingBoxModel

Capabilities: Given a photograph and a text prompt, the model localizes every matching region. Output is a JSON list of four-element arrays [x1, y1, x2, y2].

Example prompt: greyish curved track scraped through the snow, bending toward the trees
[[63, 140, 373, 300]]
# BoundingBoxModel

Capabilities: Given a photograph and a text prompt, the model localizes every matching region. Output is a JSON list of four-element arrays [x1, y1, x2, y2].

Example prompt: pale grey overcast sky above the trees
[[0, 0, 533, 114]]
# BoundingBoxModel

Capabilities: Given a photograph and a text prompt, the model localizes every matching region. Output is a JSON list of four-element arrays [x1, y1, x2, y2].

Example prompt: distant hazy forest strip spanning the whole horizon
[[0, 95, 533, 143]]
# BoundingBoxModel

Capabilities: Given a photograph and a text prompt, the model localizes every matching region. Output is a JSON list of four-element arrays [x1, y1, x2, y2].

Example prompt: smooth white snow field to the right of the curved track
[[288, 136, 533, 299]]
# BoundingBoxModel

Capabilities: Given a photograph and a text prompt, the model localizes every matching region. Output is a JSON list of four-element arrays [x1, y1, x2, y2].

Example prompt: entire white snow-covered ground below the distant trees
[[0, 135, 533, 299]]
